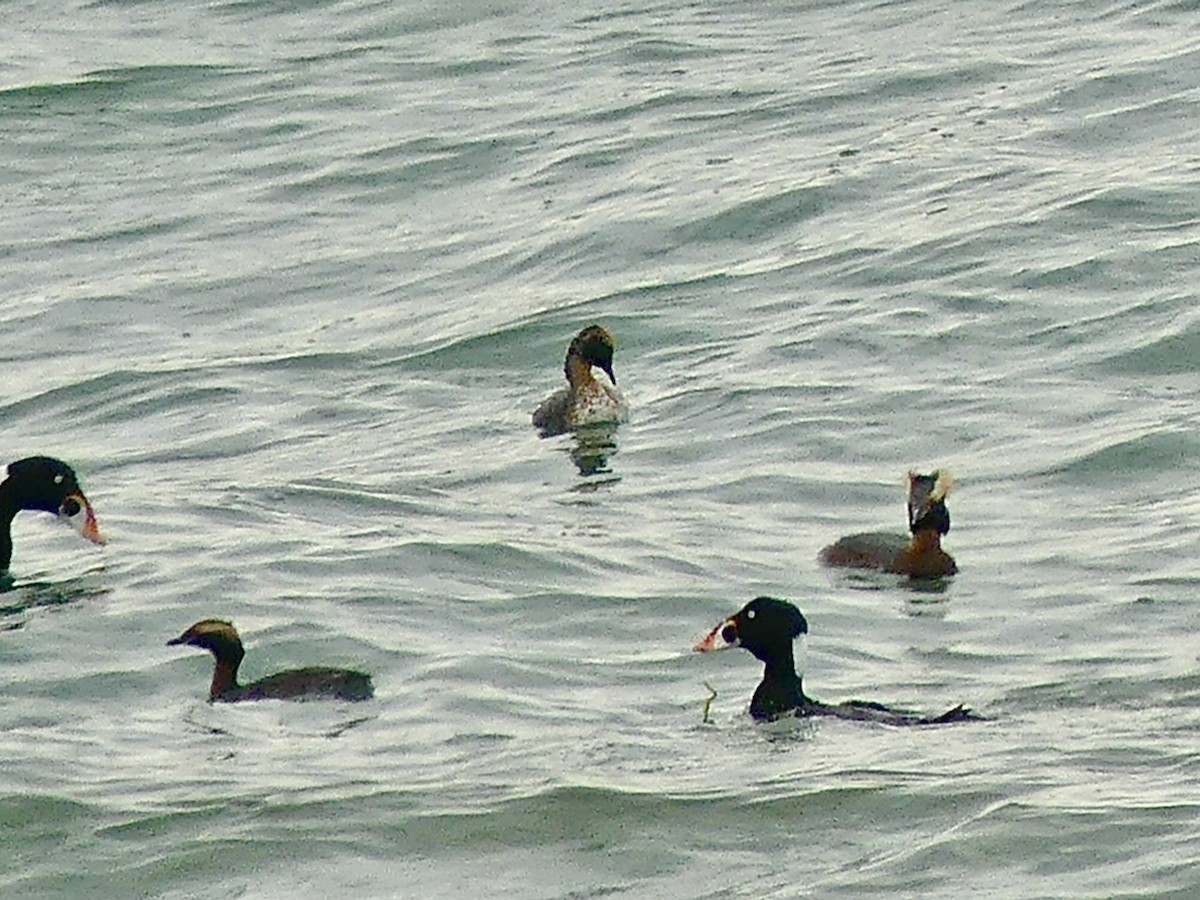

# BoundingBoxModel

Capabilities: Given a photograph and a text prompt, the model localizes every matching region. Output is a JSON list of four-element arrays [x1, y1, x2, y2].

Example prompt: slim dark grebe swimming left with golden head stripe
[[167, 619, 374, 703]]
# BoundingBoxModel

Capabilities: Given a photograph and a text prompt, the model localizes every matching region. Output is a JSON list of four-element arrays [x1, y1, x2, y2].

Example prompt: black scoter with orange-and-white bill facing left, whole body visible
[[694, 596, 980, 725]]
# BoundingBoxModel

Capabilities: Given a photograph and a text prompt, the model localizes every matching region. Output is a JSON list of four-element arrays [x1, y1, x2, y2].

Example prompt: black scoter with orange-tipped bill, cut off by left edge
[[0, 456, 106, 572]]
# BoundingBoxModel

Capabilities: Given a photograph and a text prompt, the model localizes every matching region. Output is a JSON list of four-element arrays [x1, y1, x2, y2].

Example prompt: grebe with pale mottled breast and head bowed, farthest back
[[533, 325, 629, 437]]
